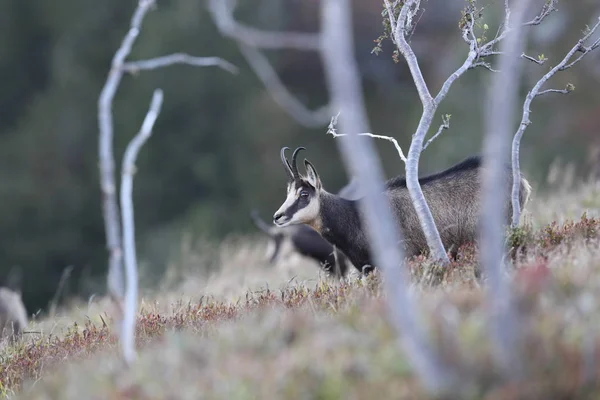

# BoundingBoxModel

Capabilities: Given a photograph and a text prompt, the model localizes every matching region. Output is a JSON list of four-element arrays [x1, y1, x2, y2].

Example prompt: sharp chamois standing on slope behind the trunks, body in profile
[[273, 147, 531, 272]]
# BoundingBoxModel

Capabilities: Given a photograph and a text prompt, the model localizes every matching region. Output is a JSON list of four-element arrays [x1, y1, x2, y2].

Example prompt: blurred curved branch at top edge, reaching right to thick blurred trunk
[[208, 0, 319, 51]]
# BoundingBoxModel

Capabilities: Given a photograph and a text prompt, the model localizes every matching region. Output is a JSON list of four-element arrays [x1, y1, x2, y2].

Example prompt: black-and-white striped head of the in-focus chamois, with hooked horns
[[273, 147, 321, 230]]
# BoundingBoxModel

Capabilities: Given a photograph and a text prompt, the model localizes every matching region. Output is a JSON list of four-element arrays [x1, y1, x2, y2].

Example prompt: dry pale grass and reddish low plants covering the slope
[[0, 180, 600, 399]]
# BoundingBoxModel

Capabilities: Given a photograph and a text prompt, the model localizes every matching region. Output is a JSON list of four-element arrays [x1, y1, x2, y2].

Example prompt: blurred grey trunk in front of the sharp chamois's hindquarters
[[480, 0, 529, 379]]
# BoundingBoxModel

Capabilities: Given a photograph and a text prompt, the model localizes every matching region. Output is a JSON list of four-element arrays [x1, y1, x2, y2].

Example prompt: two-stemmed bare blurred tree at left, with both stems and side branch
[[98, 0, 236, 362]]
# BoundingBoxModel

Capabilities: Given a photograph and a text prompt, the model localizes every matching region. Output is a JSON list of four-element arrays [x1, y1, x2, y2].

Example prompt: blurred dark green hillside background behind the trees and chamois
[[0, 0, 600, 312]]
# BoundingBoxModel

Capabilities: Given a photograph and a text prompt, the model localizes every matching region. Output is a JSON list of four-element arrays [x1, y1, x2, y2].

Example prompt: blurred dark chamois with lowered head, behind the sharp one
[[250, 210, 348, 278]]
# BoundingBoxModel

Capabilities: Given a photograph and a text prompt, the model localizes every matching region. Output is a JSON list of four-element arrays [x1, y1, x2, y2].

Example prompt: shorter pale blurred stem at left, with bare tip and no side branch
[[121, 89, 163, 364]]
